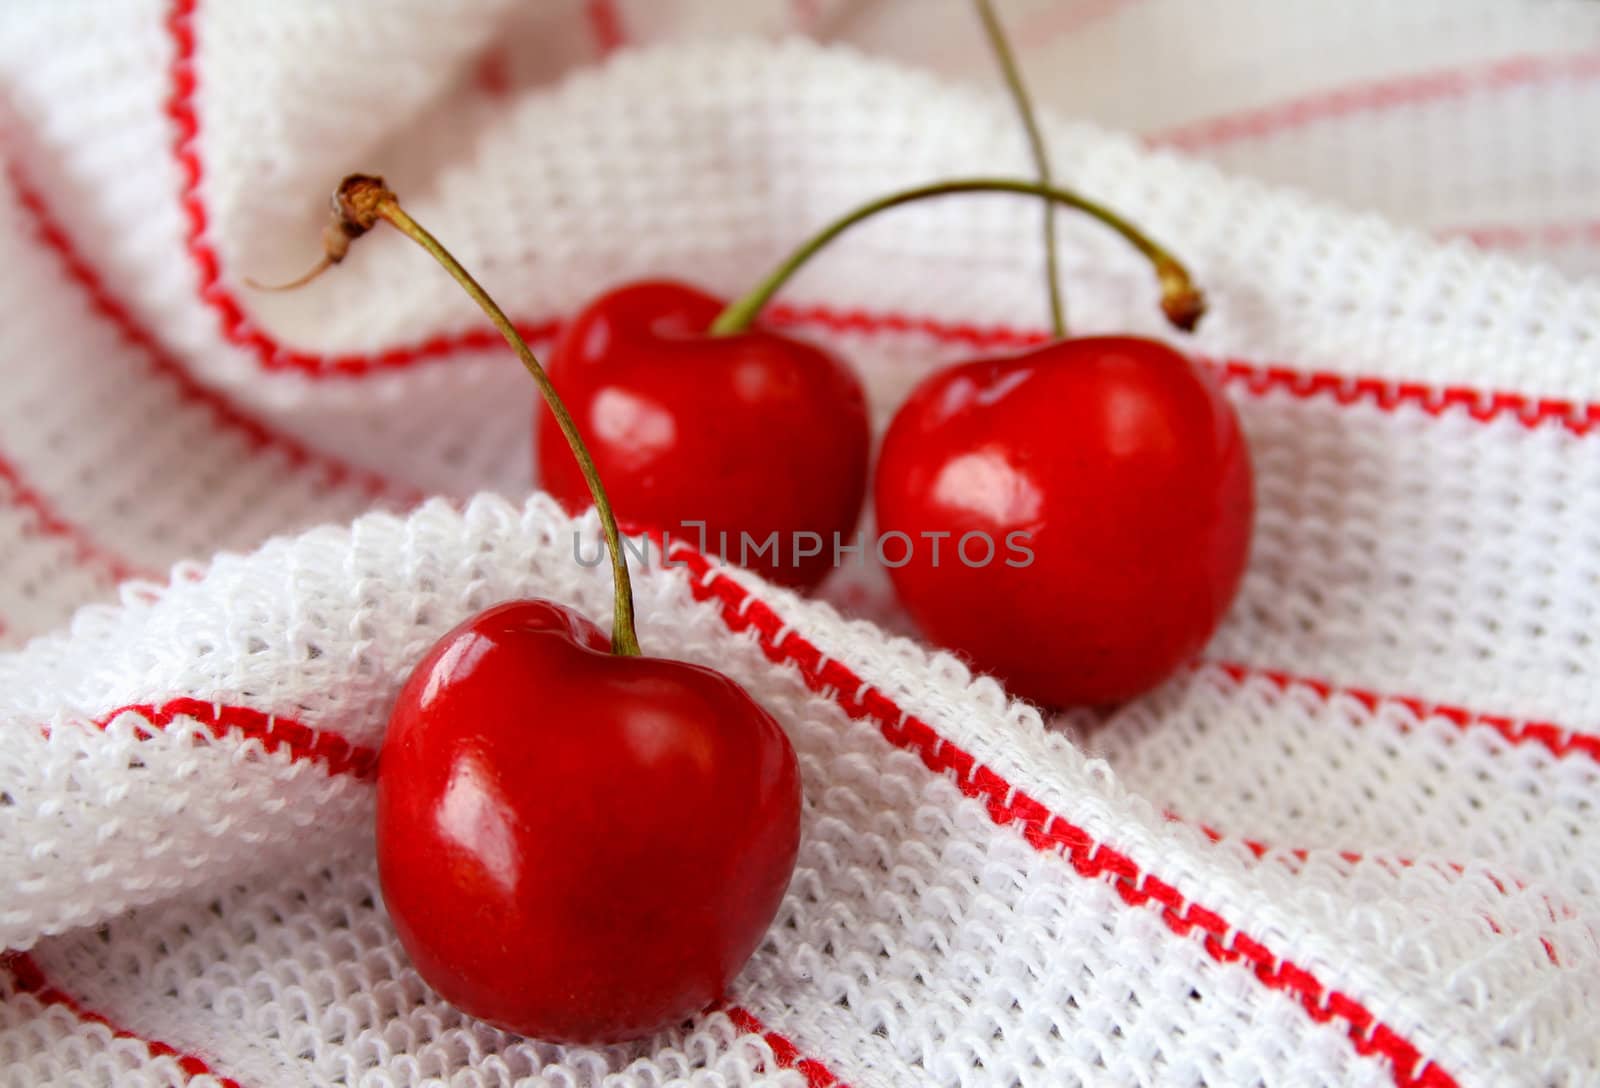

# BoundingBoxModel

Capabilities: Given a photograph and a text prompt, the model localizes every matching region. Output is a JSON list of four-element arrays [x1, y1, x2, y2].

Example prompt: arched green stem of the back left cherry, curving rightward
[[710, 178, 1205, 336]]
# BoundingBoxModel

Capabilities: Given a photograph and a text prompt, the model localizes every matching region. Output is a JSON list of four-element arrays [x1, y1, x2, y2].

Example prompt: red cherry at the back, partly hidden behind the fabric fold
[[536, 282, 869, 587]]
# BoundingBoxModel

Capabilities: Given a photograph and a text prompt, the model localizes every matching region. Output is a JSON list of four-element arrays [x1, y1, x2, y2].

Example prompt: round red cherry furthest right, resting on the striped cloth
[[875, 336, 1254, 707]]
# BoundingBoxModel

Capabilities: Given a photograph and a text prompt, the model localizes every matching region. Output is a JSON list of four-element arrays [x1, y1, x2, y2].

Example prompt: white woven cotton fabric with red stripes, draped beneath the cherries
[[0, 0, 1600, 1088]]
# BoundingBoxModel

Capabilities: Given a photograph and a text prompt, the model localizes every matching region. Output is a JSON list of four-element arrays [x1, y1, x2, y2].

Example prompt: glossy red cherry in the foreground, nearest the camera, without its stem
[[378, 600, 800, 1043]]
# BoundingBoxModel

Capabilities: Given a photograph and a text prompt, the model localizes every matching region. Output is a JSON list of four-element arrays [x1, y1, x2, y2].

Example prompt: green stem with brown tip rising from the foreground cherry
[[276, 174, 640, 656]]
